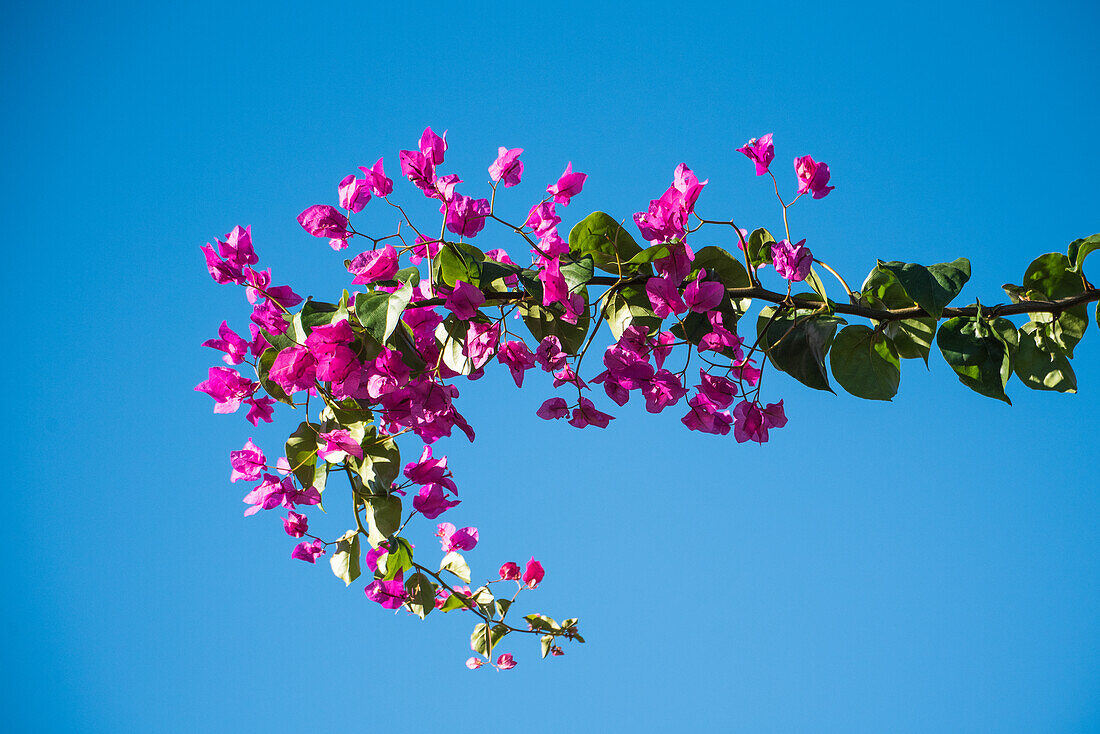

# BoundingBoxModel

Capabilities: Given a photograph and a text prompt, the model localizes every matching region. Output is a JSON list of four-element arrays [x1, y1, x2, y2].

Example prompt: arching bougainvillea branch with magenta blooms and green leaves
[[196, 128, 1100, 670]]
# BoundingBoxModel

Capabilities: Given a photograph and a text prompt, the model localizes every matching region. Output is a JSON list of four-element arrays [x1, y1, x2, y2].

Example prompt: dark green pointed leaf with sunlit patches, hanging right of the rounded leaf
[[936, 317, 1014, 405]]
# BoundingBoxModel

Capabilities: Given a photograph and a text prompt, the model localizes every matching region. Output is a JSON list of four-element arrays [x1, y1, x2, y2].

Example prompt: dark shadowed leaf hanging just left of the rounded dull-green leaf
[[757, 306, 846, 393]]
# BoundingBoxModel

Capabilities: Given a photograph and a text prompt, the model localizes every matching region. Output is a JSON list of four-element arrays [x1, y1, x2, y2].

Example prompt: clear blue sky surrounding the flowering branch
[[8, 0, 1100, 732]]
